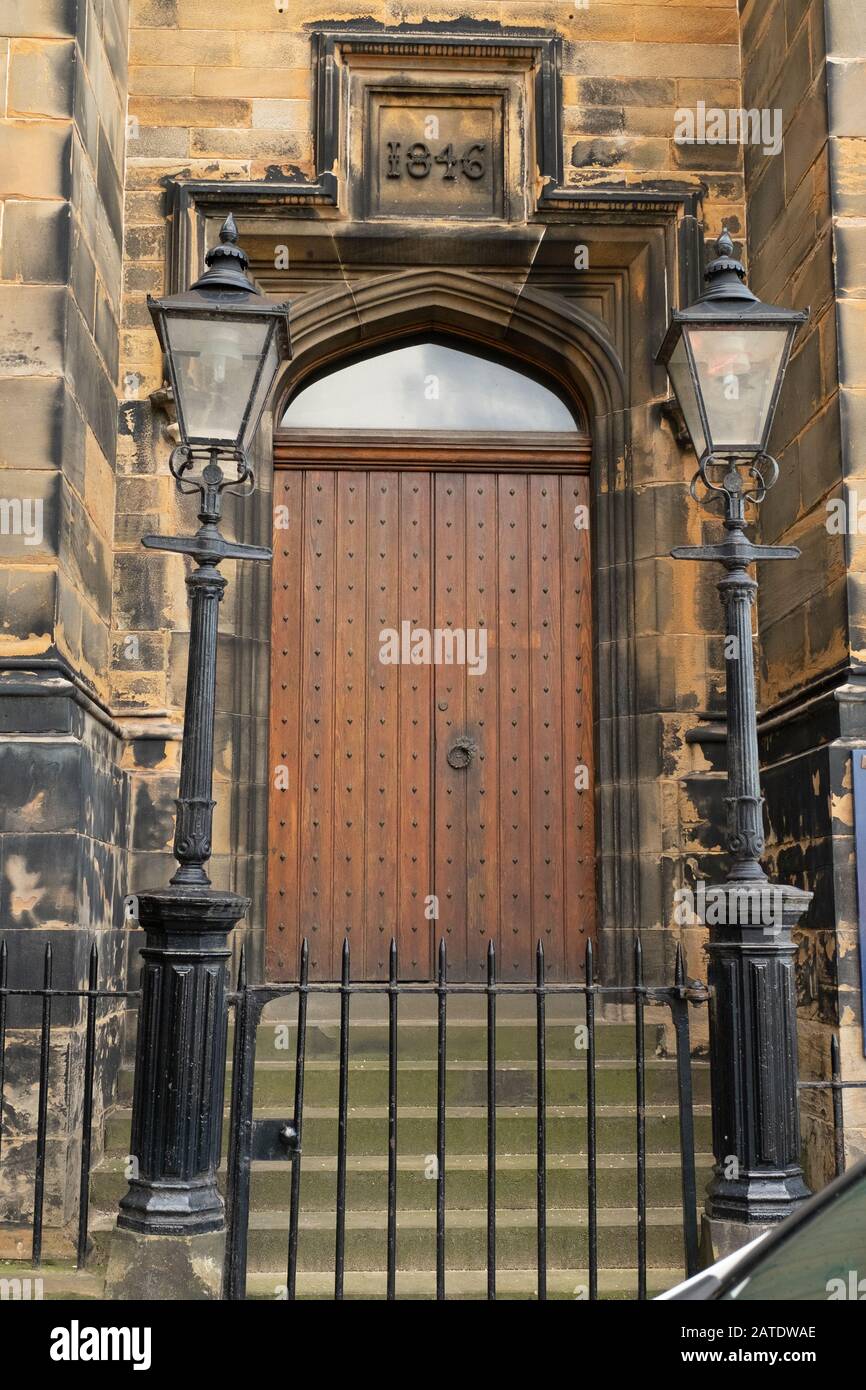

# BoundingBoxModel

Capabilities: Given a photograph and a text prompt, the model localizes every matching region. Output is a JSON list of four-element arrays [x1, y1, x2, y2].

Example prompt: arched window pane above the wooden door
[[281, 342, 580, 434]]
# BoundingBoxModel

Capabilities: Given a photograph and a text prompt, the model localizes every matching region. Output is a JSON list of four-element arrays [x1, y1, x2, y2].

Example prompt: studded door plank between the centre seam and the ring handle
[[434, 473, 467, 970]]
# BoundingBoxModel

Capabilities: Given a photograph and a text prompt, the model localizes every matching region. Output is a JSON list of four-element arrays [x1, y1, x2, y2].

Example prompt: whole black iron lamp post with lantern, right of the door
[[656, 232, 812, 1252]]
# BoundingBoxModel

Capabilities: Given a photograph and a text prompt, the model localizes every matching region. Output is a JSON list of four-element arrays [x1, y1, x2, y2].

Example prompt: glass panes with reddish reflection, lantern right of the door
[[685, 325, 790, 452]]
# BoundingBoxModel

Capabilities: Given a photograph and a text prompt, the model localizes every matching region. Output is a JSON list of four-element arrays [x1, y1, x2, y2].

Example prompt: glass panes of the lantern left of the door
[[165, 310, 271, 443]]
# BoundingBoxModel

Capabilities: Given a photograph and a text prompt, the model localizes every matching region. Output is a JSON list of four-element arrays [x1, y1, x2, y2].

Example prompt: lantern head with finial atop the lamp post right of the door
[[656, 232, 809, 463]]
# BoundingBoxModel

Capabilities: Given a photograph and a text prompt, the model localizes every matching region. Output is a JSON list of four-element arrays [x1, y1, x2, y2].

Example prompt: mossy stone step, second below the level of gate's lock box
[[93, 1208, 695, 1282]]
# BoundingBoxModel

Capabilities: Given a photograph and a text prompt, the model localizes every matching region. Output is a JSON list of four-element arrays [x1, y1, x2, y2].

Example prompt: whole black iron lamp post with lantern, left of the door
[[118, 215, 289, 1239]]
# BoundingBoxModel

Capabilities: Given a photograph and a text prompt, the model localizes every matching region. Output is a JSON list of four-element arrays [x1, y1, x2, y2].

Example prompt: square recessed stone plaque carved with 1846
[[367, 90, 505, 221]]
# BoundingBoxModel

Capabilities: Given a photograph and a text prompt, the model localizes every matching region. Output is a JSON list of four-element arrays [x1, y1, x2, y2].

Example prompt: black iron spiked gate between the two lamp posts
[[225, 940, 706, 1300]]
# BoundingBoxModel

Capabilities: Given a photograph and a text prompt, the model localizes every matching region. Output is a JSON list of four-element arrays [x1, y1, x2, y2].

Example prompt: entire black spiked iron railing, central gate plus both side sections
[[0, 941, 866, 1300]]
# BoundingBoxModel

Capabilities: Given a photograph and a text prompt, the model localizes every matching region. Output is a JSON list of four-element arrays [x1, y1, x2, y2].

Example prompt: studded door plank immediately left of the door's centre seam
[[391, 473, 436, 979]]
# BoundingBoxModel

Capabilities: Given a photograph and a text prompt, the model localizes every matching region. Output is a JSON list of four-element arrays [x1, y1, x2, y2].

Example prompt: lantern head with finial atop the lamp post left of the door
[[147, 213, 289, 456]]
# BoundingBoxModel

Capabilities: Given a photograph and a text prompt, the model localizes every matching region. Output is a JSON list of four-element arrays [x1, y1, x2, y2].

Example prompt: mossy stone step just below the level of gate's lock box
[[92, 1154, 712, 1212]]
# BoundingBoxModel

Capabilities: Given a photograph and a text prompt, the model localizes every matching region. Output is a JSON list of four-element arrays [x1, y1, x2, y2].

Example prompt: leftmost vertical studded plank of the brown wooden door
[[267, 470, 304, 980]]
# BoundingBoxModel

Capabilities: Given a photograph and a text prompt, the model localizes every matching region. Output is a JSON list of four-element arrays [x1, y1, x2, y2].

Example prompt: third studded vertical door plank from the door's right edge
[[499, 474, 532, 980]]
